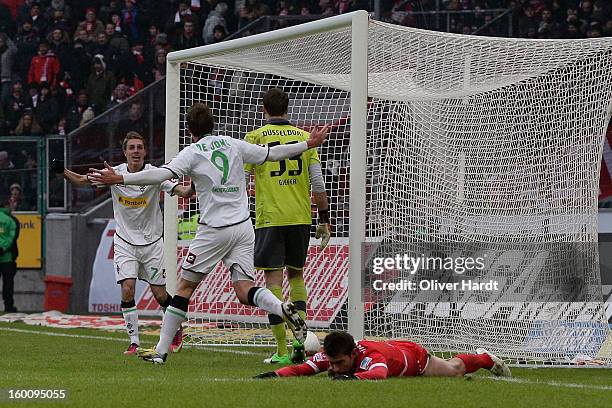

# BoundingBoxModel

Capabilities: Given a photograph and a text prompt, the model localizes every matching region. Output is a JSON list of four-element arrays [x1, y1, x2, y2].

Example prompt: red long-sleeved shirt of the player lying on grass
[[276, 340, 429, 380]]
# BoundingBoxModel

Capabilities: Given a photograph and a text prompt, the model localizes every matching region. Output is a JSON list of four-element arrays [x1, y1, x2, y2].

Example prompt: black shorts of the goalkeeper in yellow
[[255, 225, 310, 271]]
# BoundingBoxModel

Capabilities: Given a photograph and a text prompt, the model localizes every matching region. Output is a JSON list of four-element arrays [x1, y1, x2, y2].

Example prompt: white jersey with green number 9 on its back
[[162, 135, 269, 228]]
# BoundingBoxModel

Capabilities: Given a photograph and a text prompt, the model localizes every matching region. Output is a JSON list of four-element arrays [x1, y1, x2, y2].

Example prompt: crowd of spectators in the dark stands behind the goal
[[0, 0, 612, 208]]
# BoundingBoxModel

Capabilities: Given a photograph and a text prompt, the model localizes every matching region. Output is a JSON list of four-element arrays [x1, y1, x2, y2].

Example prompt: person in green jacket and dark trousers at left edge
[[0, 193, 19, 313]]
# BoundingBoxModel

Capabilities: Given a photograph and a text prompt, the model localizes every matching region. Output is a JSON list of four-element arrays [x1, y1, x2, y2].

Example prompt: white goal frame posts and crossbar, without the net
[[164, 10, 369, 339]]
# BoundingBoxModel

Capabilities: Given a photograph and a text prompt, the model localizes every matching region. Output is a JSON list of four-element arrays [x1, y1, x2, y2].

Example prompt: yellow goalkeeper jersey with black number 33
[[244, 120, 320, 228]]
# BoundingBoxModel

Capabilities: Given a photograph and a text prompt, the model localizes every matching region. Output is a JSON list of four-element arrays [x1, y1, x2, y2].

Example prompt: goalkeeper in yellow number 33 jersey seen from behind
[[245, 88, 330, 364]]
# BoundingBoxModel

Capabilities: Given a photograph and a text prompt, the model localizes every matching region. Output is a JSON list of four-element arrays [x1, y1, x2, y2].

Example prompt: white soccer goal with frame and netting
[[164, 11, 612, 364]]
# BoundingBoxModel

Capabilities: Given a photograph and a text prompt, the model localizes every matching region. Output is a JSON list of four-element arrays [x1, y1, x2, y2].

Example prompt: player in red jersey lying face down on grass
[[255, 332, 512, 380]]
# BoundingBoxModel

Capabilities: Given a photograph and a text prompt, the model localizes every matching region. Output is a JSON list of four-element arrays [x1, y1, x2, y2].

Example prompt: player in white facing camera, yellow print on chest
[[53, 132, 194, 355]]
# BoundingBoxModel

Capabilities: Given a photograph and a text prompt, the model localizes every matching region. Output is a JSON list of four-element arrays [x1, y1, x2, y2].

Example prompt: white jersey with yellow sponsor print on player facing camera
[[111, 163, 177, 245]]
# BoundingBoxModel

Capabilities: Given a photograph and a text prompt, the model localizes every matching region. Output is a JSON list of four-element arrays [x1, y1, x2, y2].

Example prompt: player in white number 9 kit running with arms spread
[[87, 103, 327, 364]]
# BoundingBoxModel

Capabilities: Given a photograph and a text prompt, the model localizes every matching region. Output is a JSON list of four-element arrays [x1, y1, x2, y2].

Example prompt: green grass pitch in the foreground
[[0, 323, 612, 408]]
